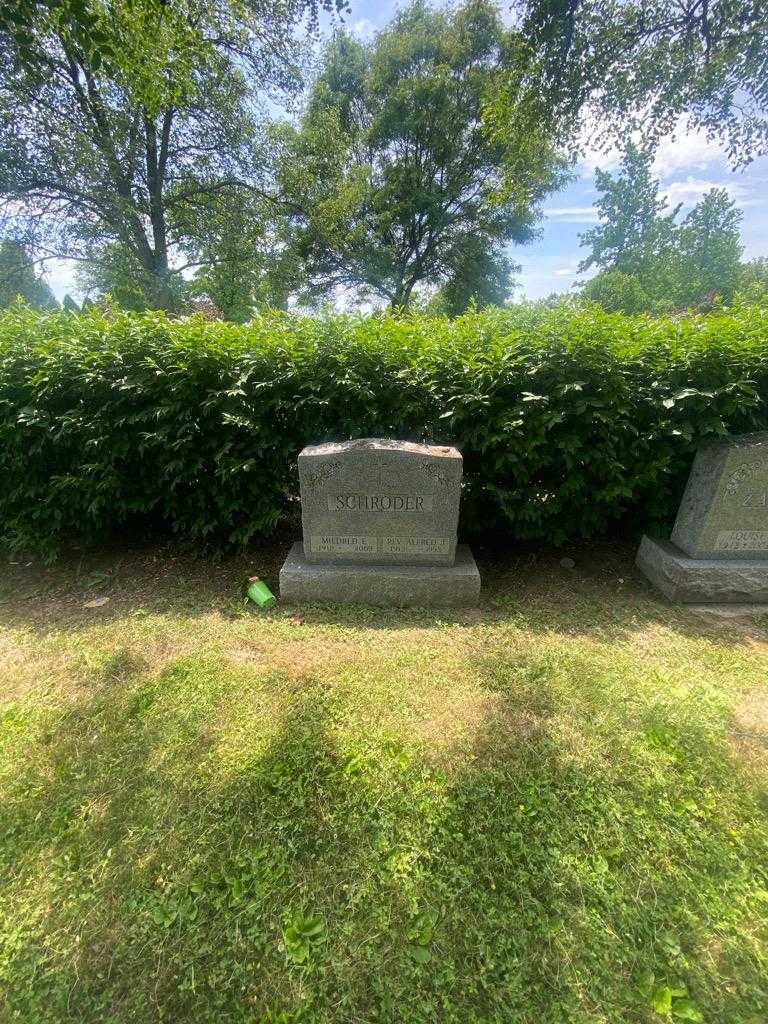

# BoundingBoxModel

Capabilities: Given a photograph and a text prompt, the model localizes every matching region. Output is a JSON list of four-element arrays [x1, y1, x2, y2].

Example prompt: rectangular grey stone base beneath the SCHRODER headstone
[[280, 542, 480, 608]]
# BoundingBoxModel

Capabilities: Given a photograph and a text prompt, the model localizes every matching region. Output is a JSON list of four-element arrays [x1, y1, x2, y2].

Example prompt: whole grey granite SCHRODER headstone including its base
[[281, 438, 480, 606]]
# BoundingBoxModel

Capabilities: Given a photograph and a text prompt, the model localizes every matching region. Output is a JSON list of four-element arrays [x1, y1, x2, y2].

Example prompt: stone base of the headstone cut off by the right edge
[[636, 537, 768, 604]]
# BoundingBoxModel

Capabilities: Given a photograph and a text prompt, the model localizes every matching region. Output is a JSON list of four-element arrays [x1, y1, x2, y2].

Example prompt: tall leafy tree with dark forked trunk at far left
[[0, 0, 341, 309]]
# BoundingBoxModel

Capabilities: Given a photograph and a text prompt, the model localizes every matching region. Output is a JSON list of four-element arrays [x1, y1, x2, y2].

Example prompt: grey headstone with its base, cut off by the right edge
[[637, 433, 768, 603]]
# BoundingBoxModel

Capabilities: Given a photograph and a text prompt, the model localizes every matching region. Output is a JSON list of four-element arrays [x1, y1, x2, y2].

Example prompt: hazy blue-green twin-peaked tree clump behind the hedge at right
[[579, 144, 741, 312]]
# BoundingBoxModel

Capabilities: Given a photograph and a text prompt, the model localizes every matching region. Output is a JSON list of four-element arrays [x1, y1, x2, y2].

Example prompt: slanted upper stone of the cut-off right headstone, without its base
[[672, 431, 768, 559]]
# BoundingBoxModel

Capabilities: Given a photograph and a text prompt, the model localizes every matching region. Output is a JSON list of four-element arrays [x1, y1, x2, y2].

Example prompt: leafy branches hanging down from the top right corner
[[486, 0, 768, 166]]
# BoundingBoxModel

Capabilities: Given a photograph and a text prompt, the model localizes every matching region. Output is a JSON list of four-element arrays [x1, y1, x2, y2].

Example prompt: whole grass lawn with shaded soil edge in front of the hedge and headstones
[[0, 548, 768, 1024]]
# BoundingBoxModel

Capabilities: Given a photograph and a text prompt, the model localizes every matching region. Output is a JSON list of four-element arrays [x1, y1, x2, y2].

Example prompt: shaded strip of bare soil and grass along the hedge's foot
[[0, 543, 768, 645]]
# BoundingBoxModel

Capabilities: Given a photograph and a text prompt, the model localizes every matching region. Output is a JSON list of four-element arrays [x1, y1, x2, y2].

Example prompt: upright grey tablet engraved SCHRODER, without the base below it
[[299, 437, 462, 565]]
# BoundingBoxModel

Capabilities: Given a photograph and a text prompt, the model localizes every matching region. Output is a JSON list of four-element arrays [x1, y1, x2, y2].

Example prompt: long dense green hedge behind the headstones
[[0, 307, 768, 554]]
